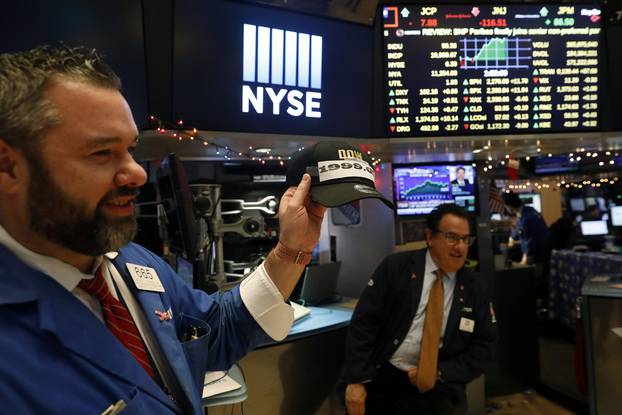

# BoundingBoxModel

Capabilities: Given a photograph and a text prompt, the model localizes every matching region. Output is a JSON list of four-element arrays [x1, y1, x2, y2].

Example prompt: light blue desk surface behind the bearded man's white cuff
[[258, 300, 355, 348]]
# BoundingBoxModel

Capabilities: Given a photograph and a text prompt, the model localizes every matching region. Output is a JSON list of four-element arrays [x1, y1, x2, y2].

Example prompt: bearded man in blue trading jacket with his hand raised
[[0, 46, 325, 415]]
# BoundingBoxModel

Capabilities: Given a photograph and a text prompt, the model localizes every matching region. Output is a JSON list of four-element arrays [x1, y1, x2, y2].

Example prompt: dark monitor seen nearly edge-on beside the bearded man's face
[[157, 154, 198, 262]]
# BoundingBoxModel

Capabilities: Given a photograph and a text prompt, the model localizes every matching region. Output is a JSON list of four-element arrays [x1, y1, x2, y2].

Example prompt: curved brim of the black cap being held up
[[311, 183, 395, 210]]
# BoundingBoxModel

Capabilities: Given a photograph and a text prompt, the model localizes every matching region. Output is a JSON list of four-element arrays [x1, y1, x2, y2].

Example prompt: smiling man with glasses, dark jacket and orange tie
[[342, 204, 497, 415]]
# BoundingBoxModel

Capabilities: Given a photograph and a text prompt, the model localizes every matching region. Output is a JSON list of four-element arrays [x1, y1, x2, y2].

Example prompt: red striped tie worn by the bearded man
[[78, 266, 154, 378]]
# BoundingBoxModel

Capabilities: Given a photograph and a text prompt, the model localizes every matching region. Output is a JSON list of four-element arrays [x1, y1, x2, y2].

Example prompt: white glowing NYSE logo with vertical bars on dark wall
[[242, 24, 322, 118]]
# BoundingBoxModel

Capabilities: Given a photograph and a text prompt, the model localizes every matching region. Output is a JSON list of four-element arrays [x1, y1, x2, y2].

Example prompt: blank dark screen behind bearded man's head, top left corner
[[0, 0, 148, 128]]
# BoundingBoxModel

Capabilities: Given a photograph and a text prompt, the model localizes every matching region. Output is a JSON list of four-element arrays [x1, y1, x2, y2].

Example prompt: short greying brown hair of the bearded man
[[0, 45, 121, 156]]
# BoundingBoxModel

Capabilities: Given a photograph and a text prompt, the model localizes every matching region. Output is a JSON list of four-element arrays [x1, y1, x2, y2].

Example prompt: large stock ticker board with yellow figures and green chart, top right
[[382, 4, 604, 137]]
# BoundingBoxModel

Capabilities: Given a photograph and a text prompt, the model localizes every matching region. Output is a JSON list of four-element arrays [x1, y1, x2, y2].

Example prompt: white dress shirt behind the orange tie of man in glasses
[[389, 250, 456, 371]]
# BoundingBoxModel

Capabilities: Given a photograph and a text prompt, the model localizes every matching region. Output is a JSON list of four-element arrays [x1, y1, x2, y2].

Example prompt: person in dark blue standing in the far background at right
[[503, 192, 550, 265]]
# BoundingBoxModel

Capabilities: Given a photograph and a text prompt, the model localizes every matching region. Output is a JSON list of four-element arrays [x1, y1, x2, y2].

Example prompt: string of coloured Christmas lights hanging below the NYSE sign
[[149, 115, 382, 167]]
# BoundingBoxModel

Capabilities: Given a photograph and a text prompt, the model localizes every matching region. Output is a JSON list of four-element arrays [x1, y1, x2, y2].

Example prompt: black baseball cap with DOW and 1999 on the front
[[287, 141, 395, 209]]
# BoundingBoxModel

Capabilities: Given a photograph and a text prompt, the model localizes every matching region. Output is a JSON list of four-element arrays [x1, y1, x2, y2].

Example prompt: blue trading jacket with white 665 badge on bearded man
[[0, 244, 266, 415]]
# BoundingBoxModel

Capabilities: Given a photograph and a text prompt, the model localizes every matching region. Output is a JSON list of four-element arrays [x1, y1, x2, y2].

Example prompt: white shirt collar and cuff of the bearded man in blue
[[0, 226, 294, 341]]
